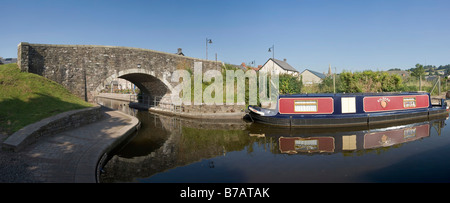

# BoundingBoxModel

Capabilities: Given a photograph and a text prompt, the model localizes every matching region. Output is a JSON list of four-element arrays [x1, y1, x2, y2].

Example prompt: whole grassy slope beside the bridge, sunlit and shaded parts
[[0, 64, 92, 134]]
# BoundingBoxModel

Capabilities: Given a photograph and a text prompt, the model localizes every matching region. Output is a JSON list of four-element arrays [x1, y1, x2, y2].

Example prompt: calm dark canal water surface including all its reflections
[[98, 98, 450, 183]]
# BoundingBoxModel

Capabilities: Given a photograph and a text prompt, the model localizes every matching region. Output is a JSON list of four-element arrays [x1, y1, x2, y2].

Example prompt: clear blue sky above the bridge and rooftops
[[0, 0, 450, 72]]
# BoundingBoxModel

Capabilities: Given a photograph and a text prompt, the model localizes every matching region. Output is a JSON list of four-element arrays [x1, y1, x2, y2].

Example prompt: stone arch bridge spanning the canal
[[17, 42, 222, 101]]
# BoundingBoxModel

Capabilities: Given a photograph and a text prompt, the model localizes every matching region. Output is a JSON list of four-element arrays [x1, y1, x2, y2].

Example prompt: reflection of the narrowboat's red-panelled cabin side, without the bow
[[278, 120, 444, 154]]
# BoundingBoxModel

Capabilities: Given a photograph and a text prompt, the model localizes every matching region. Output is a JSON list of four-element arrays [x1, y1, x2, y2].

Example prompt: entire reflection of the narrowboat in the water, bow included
[[248, 117, 448, 154]]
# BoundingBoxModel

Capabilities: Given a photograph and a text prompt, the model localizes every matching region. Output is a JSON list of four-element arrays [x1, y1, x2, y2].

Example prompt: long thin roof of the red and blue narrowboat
[[279, 92, 430, 98]]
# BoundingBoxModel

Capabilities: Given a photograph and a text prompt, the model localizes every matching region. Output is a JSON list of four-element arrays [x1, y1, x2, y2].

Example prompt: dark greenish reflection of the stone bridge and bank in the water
[[97, 98, 250, 182]]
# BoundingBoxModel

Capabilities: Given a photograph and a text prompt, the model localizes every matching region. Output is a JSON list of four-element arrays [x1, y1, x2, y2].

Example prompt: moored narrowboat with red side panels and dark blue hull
[[248, 92, 448, 128]]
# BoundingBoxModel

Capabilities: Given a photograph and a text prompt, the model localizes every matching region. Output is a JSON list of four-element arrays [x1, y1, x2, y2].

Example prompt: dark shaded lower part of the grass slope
[[0, 93, 90, 135]]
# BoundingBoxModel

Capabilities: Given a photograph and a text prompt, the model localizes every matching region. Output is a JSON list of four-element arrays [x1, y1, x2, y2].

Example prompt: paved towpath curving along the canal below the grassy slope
[[0, 107, 139, 183]]
